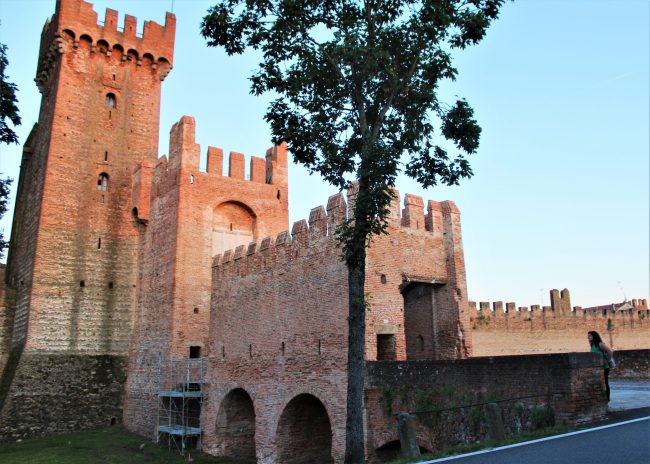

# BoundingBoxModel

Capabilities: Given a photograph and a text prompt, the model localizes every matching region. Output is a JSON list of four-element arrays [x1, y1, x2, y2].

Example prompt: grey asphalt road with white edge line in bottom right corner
[[420, 417, 650, 464]]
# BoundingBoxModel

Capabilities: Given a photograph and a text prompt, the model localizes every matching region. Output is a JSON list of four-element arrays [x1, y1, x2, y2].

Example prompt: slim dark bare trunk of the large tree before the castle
[[345, 225, 366, 464]]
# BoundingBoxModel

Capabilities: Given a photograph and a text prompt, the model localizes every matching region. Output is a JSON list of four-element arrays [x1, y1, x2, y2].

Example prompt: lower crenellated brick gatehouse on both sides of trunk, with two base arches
[[202, 191, 471, 463]]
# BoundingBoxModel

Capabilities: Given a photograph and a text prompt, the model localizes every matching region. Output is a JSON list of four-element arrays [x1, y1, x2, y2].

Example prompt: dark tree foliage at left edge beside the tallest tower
[[0, 43, 20, 258]]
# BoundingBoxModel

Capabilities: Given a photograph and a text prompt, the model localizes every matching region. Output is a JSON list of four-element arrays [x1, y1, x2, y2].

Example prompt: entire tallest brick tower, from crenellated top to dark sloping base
[[0, 0, 176, 437]]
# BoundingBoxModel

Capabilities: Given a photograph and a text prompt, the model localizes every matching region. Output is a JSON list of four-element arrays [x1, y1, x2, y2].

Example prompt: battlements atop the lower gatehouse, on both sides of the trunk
[[212, 187, 459, 267]]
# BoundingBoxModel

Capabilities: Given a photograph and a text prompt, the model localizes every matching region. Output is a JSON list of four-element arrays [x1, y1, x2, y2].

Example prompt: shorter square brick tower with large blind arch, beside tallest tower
[[125, 116, 288, 436]]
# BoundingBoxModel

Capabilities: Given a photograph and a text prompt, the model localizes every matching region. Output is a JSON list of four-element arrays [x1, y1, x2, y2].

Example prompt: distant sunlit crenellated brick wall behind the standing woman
[[470, 289, 650, 356]]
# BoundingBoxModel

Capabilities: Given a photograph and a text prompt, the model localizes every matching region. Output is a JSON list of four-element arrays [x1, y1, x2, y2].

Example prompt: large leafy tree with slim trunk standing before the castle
[[202, 0, 503, 463]]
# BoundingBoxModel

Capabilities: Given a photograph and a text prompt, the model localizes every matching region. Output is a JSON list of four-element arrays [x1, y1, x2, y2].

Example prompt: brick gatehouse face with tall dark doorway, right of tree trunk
[[366, 191, 472, 360]]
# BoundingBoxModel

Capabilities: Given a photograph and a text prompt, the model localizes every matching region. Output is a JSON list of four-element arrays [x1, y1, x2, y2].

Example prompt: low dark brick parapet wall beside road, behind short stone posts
[[366, 353, 607, 461]]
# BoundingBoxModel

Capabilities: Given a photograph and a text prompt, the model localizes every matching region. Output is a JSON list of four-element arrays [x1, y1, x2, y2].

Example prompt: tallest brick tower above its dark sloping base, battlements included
[[5, 0, 175, 353]]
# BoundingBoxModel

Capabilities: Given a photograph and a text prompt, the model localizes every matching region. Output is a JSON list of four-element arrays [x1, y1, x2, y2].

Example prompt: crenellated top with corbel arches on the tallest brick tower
[[35, 0, 176, 94]]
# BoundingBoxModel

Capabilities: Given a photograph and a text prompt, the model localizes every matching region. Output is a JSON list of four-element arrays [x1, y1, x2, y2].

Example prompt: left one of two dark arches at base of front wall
[[215, 388, 255, 462]]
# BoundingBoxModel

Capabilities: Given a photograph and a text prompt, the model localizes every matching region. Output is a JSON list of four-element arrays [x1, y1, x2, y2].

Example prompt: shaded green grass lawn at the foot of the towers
[[0, 426, 248, 464]]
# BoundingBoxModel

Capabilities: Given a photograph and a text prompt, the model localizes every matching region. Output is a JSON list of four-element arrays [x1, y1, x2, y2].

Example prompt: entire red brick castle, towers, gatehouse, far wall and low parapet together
[[0, 0, 648, 456]]
